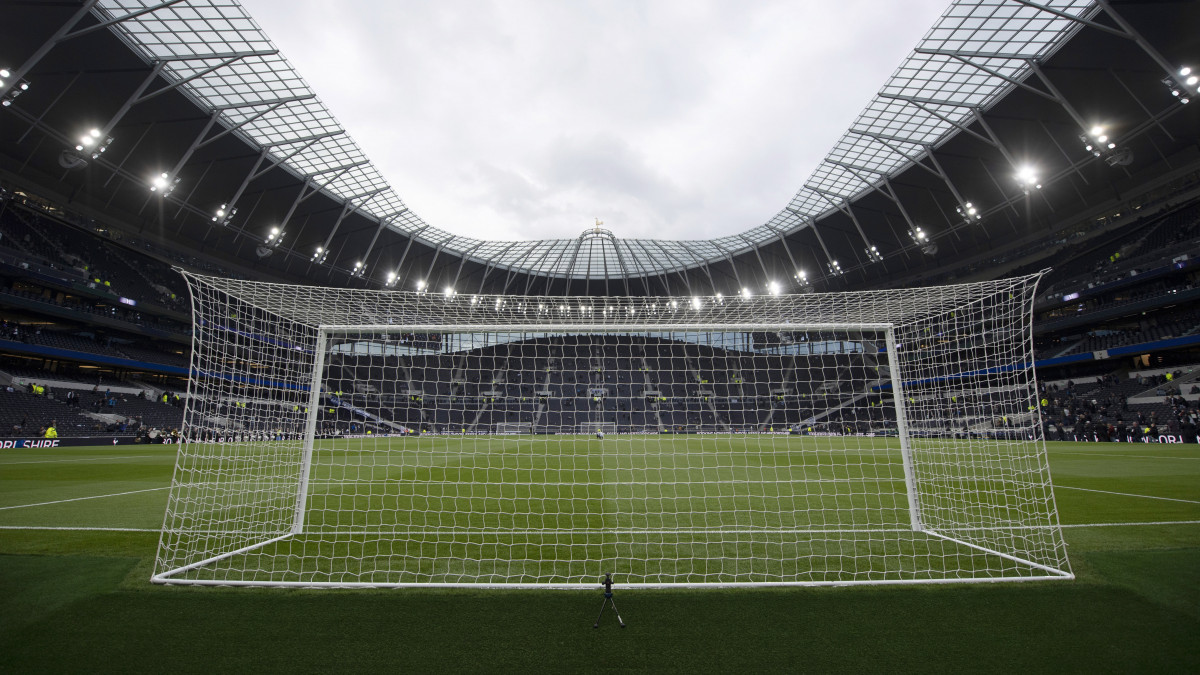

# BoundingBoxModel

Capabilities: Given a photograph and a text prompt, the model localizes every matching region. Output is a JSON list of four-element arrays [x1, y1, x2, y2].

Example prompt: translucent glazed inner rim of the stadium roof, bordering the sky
[[94, 0, 1099, 279]]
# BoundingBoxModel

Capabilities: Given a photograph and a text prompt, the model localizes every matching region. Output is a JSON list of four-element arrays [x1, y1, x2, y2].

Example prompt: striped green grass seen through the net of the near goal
[[163, 435, 1066, 586]]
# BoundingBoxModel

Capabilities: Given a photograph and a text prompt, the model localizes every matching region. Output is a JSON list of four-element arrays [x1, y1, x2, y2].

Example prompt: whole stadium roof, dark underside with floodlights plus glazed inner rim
[[0, 0, 1200, 293]]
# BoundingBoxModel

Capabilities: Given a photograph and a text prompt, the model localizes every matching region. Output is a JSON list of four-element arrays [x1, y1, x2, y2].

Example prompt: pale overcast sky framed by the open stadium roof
[[242, 0, 948, 239]]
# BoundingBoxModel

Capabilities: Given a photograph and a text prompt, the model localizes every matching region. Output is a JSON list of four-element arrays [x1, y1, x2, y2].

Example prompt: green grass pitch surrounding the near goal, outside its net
[[0, 443, 1200, 673]]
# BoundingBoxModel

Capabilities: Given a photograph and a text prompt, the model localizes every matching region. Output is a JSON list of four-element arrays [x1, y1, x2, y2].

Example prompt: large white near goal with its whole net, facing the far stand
[[152, 267, 1073, 587]]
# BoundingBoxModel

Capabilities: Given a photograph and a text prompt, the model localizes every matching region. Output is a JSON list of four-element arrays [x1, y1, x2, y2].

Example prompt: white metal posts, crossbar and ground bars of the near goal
[[151, 322, 1074, 589]]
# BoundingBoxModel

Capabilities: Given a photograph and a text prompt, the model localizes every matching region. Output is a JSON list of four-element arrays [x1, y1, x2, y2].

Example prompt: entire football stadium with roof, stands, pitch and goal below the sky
[[0, 0, 1200, 673]]
